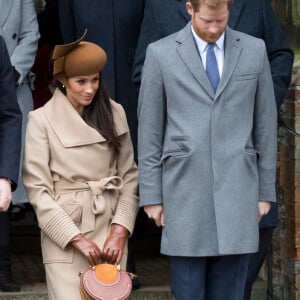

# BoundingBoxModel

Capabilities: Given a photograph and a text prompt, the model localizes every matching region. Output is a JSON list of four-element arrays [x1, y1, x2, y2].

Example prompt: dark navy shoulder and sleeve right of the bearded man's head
[[228, 0, 294, 109]]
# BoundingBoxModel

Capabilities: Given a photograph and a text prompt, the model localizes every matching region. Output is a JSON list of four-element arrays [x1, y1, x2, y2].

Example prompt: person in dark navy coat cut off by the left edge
[[0, 36, 22, 292]]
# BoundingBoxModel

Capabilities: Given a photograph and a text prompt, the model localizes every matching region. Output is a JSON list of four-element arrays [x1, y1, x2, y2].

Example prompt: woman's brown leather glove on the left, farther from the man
[[70, 234, 102, 266]]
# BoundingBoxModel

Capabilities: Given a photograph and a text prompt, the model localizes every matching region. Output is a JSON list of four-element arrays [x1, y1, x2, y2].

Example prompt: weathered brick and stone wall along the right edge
[[273, 67, 300, 300]]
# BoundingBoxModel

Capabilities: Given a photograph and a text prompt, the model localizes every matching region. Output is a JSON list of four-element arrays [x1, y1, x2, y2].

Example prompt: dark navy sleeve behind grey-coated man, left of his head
[[132, 0, 163, 87]]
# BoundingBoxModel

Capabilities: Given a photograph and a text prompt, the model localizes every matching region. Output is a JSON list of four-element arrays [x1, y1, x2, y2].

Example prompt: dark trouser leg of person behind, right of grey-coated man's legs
[[244, 227, 275, 300]]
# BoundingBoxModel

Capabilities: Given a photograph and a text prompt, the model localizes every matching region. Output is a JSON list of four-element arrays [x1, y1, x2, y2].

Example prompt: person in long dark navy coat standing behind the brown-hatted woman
[[59, 0, 145, 288]]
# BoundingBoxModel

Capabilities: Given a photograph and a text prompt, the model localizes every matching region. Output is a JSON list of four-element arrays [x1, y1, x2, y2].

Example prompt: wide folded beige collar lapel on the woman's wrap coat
[[44, 89, 105, 148]]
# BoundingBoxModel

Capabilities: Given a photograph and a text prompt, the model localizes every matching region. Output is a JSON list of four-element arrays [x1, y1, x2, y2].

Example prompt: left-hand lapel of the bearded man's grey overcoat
[[176, 22, 214, 98]]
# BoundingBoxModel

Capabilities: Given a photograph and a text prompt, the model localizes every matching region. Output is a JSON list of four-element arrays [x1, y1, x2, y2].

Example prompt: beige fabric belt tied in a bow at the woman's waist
[[54, 176, 123, 233]]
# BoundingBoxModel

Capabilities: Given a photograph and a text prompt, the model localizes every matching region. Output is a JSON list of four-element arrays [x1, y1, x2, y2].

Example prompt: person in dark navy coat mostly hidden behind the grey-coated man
[[133, 0, 293, 300]]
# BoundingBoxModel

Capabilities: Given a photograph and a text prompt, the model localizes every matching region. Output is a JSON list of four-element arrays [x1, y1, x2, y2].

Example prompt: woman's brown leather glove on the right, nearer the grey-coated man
[[102, 224, 129, 264]]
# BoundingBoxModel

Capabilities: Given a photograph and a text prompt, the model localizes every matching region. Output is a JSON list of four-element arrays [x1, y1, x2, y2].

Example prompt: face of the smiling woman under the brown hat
[[66, 73, 100, 114]]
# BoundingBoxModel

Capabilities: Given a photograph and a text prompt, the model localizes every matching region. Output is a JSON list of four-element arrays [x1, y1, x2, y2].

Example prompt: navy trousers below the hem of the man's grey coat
[[170, 254, 249, 300]]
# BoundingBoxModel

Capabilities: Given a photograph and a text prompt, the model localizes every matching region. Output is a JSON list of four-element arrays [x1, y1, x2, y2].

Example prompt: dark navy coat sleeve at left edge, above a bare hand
[[0, 36, 22, 190]]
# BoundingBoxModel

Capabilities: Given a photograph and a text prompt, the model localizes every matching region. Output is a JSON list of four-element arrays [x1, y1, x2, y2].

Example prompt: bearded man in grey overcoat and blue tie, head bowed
[[138, 0, 277, 300]]
